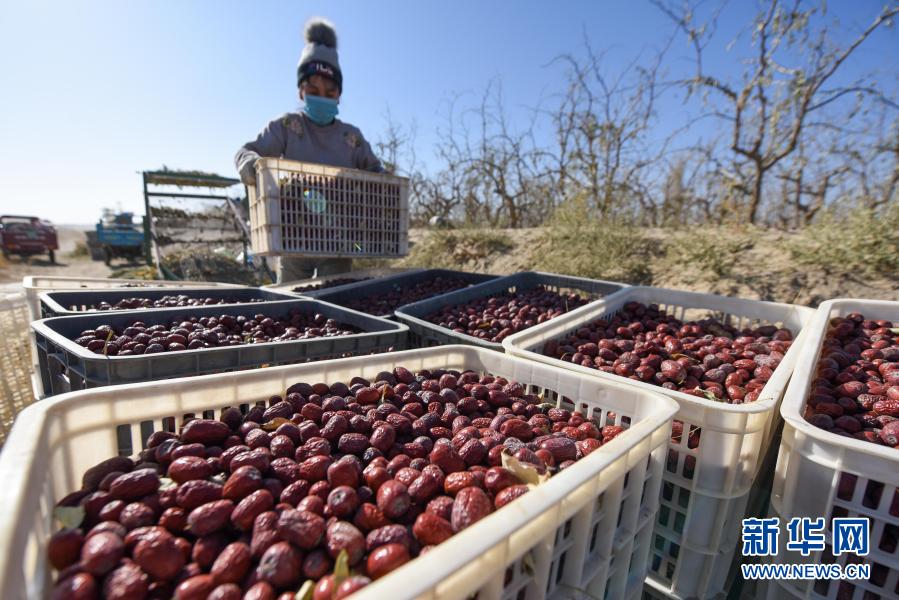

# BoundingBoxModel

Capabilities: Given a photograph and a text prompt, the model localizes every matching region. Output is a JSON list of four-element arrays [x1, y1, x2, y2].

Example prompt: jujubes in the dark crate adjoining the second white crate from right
[[428, 285, 589, 343]]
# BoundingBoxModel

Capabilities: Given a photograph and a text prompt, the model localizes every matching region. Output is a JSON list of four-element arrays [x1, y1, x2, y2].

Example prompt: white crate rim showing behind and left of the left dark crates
[[22, 275, 246, 398]]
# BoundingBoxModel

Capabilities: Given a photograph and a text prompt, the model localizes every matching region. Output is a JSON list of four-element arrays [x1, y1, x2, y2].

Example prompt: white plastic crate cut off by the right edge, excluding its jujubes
[[760, 299, 899, 600]]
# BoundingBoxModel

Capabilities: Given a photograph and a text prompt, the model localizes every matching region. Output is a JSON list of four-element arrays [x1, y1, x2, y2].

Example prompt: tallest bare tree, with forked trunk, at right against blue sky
[[651, 0, 899, 223]]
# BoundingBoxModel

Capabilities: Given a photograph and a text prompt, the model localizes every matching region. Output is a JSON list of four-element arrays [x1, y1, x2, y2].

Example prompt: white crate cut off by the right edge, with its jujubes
[[759, 299, 899, 600]]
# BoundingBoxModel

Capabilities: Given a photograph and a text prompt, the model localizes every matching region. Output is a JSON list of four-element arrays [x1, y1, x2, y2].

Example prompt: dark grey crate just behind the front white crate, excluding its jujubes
[[32, 299, 407, 396]]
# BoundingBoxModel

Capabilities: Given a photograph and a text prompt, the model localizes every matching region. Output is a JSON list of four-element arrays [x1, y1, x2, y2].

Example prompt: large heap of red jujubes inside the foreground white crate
[[48, 367, 623, 600]]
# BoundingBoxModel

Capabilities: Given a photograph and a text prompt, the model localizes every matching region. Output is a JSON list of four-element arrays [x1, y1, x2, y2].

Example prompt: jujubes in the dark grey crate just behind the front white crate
[[75, 309, 358, 356]]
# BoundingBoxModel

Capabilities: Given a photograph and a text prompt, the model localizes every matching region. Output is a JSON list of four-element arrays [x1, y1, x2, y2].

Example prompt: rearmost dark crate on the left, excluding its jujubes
[[39, 288, 296, 319]]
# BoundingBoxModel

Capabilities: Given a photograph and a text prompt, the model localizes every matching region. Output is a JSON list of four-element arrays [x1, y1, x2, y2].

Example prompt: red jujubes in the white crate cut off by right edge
[[805, 313, 899, 448]]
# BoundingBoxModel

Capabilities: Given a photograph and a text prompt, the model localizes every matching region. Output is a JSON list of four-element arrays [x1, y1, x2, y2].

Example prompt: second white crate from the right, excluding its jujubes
[[503, 287, 814, 598]]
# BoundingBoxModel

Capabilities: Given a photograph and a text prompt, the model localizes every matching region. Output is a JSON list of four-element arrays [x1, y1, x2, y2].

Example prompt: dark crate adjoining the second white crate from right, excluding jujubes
[[396, 271, 628, 352]]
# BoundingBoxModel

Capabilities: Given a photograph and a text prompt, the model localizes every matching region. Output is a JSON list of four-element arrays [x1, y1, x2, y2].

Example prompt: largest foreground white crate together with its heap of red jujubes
[[0, 346, 677, 600]]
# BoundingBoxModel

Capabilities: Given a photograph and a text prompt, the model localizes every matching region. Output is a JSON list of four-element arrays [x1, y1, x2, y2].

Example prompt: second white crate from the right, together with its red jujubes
[[503, 287, 814, 598]]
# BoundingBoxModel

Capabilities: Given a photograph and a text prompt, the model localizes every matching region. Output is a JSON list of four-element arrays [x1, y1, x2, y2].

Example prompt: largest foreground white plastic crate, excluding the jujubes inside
[[0, 346, 677, 600]]
